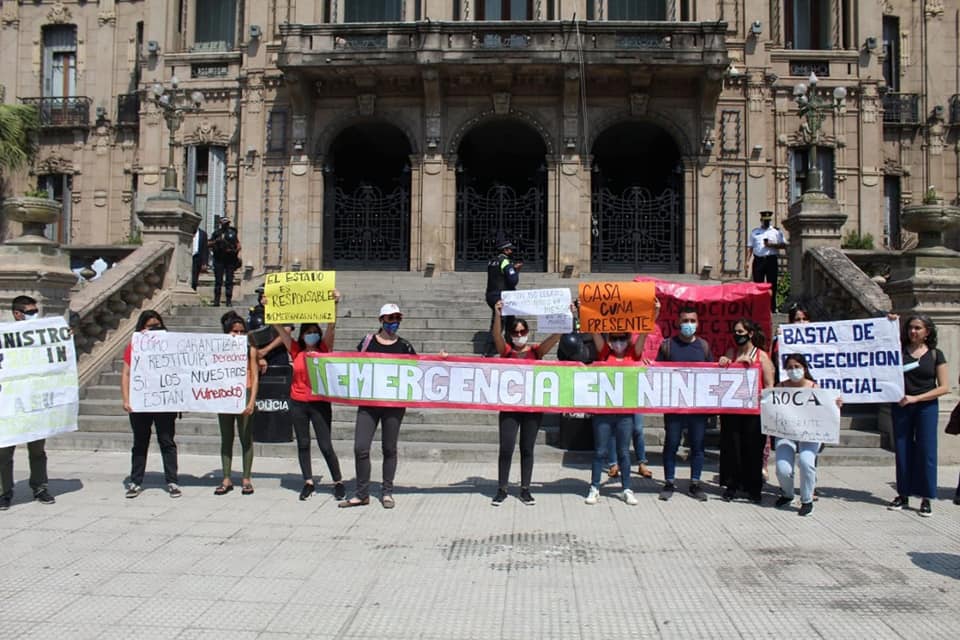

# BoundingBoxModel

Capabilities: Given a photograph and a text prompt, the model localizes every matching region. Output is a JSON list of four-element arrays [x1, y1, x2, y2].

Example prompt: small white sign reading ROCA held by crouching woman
[[760, 387, 840, 444]]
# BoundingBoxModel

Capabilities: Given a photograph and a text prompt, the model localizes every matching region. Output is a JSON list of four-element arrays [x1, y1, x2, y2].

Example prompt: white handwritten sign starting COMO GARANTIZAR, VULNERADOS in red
[[130, 331, 249, 413]]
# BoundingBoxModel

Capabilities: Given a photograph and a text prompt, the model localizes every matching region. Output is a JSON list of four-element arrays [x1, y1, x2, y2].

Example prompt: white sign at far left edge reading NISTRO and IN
[[0, 318, 80, 447]]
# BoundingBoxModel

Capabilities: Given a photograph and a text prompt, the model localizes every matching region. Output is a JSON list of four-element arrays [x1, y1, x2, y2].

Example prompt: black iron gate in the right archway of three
[[591, 187, 683, 273]]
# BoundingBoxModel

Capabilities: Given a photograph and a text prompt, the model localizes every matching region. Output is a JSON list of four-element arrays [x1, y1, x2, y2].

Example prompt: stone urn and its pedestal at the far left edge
[[0, 198, 77, 321]]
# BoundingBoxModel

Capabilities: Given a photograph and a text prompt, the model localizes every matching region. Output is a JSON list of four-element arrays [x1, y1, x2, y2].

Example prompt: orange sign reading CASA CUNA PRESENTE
[[580, 282, 656, 333]]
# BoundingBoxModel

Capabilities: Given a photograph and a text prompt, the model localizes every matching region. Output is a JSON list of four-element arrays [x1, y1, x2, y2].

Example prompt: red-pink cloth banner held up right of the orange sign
[[636, 276, 772, 359]]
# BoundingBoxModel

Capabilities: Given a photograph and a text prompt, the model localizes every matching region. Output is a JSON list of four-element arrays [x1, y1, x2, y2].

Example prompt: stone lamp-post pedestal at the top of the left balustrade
[[137, 189, 200, 305]]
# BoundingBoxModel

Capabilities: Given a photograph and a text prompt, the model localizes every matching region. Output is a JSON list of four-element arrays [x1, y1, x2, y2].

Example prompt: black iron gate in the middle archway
[[455, 185, 547, 271]]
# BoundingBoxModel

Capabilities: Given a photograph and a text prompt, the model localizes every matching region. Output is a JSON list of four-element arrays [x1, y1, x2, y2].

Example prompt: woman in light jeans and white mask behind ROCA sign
[[776, 354, 841, 516]]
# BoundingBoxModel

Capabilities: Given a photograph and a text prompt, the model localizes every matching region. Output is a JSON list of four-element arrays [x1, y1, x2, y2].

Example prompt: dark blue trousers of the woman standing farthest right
[[893, 399, 939, 498]]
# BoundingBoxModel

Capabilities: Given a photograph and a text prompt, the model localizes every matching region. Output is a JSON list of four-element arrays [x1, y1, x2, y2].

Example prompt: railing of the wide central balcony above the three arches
[[278, 21, 728, 69]]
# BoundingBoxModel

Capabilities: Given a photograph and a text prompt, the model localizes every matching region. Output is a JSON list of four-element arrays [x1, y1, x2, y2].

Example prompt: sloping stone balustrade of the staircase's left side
[[70, 241, 174, 386]]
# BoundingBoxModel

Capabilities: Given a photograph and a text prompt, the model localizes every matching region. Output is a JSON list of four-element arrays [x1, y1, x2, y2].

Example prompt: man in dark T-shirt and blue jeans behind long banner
[[657, 305, 713, 501]]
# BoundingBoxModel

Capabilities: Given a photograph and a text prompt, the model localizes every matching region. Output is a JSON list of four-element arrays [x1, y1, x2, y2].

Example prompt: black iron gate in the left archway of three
[[325, 185, 410, 271]]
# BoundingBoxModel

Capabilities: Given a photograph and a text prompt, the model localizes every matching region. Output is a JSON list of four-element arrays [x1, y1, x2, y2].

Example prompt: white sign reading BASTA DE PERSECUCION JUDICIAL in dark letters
[[777, 318, 903, 403]]
